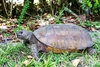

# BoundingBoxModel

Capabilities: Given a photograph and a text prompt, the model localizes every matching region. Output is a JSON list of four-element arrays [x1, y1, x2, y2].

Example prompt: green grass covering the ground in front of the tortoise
[[0, 33, 100, 67]]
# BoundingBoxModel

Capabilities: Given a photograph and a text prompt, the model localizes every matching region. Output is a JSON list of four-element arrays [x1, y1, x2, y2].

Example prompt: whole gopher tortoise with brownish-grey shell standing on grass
[[16, 23, 96, 60]]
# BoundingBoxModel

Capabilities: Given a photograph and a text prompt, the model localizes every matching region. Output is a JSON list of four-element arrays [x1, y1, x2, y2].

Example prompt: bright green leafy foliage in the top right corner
[[81, 0, 100, 14]]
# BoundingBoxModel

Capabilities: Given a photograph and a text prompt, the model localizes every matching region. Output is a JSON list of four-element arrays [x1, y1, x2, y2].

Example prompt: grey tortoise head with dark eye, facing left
[[16, 30, 32, 40]]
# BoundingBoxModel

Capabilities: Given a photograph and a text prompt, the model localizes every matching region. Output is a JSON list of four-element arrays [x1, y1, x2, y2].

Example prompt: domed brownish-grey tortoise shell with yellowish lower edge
[[33, 23, 93, 53]]
